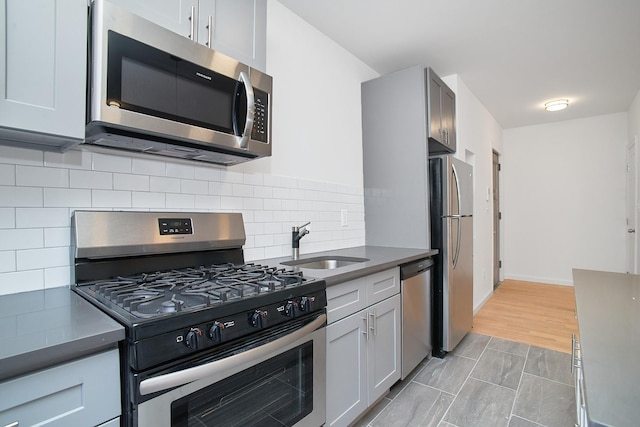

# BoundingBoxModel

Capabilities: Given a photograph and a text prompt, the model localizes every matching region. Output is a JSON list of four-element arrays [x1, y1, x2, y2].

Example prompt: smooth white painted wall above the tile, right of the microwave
[[242, 0, 379, 187]]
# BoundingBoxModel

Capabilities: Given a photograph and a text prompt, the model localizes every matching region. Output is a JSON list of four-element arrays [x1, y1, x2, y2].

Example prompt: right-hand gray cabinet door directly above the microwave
[[198, 0, 267, 71]]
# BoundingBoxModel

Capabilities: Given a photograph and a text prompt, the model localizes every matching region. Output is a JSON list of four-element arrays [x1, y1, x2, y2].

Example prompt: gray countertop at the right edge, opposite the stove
[[573, 269, 640, 427]]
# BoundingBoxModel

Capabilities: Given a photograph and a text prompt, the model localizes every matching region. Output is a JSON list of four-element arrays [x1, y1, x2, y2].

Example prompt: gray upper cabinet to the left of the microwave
[[0, 0, 88, 150]]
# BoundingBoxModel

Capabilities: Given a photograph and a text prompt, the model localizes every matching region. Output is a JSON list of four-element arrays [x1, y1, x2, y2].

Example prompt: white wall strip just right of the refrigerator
[[443, 75, 502, 312]]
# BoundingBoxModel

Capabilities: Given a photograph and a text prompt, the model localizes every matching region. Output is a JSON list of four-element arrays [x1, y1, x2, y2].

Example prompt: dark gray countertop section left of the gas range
[[0, 287, 125, 381]]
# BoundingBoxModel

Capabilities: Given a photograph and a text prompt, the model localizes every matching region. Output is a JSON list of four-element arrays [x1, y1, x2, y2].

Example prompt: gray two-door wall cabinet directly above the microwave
[[111, 0, 267, 71]]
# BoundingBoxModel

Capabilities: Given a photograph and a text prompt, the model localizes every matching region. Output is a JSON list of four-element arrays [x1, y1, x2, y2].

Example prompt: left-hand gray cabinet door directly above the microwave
[[109, 0, 198, 40]]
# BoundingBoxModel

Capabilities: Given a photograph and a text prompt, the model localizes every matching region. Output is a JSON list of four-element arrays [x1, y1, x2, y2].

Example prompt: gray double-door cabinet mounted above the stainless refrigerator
[[426, 68, 456, 154]]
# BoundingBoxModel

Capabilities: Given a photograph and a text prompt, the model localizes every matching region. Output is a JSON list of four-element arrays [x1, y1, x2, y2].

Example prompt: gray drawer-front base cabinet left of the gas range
[[0, 349, 121, 427]]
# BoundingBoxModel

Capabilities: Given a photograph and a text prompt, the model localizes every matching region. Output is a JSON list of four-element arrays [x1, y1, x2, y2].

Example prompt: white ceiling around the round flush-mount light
[[279, 0, 640, 129]]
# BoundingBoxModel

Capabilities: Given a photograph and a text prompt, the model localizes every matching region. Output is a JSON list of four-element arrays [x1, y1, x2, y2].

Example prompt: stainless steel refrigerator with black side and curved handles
[[429, 156, 473, 357]]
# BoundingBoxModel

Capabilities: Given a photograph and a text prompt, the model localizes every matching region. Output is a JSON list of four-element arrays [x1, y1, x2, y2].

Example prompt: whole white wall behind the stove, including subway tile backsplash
[[0, 0, 377, 294]]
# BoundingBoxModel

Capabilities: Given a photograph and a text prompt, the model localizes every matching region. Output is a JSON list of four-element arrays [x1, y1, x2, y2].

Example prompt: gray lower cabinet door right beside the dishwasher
[[367, 295, 401, 404]]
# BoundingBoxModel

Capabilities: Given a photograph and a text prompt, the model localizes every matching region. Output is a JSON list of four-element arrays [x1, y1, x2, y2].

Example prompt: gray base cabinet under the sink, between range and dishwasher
[[327, 269, 401, 426]]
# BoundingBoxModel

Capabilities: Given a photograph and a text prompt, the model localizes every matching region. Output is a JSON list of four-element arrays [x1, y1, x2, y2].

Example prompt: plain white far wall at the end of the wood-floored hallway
[[502, 113, 628, 284]]
